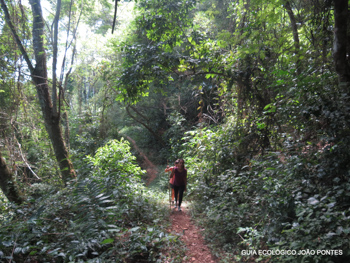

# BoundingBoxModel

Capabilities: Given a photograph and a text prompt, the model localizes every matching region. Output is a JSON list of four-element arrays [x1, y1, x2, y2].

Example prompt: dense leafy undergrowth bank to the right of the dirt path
[[183, 108, 350, 262]]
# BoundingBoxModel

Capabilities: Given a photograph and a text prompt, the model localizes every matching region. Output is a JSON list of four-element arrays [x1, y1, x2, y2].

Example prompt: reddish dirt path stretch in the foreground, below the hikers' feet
[[170, 202, 218, 263]]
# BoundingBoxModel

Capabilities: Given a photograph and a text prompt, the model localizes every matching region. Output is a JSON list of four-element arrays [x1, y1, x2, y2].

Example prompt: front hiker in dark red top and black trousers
[[170, 159, 187, 211]]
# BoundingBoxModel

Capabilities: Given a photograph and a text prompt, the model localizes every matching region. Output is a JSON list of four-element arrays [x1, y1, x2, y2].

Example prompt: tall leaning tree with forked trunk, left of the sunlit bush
[[0, 0, 76, 186]]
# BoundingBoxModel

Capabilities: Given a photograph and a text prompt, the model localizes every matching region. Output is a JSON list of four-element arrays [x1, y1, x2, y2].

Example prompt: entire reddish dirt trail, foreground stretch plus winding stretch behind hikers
[[126, 136, 217, 263]]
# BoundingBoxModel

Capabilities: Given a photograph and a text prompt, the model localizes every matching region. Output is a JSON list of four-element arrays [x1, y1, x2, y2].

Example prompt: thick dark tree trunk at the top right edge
[[333, 0, 350, 87]]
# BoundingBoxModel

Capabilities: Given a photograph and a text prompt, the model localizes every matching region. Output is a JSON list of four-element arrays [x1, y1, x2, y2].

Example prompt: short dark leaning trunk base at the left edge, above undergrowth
[[0, 152, 23, 204]]
